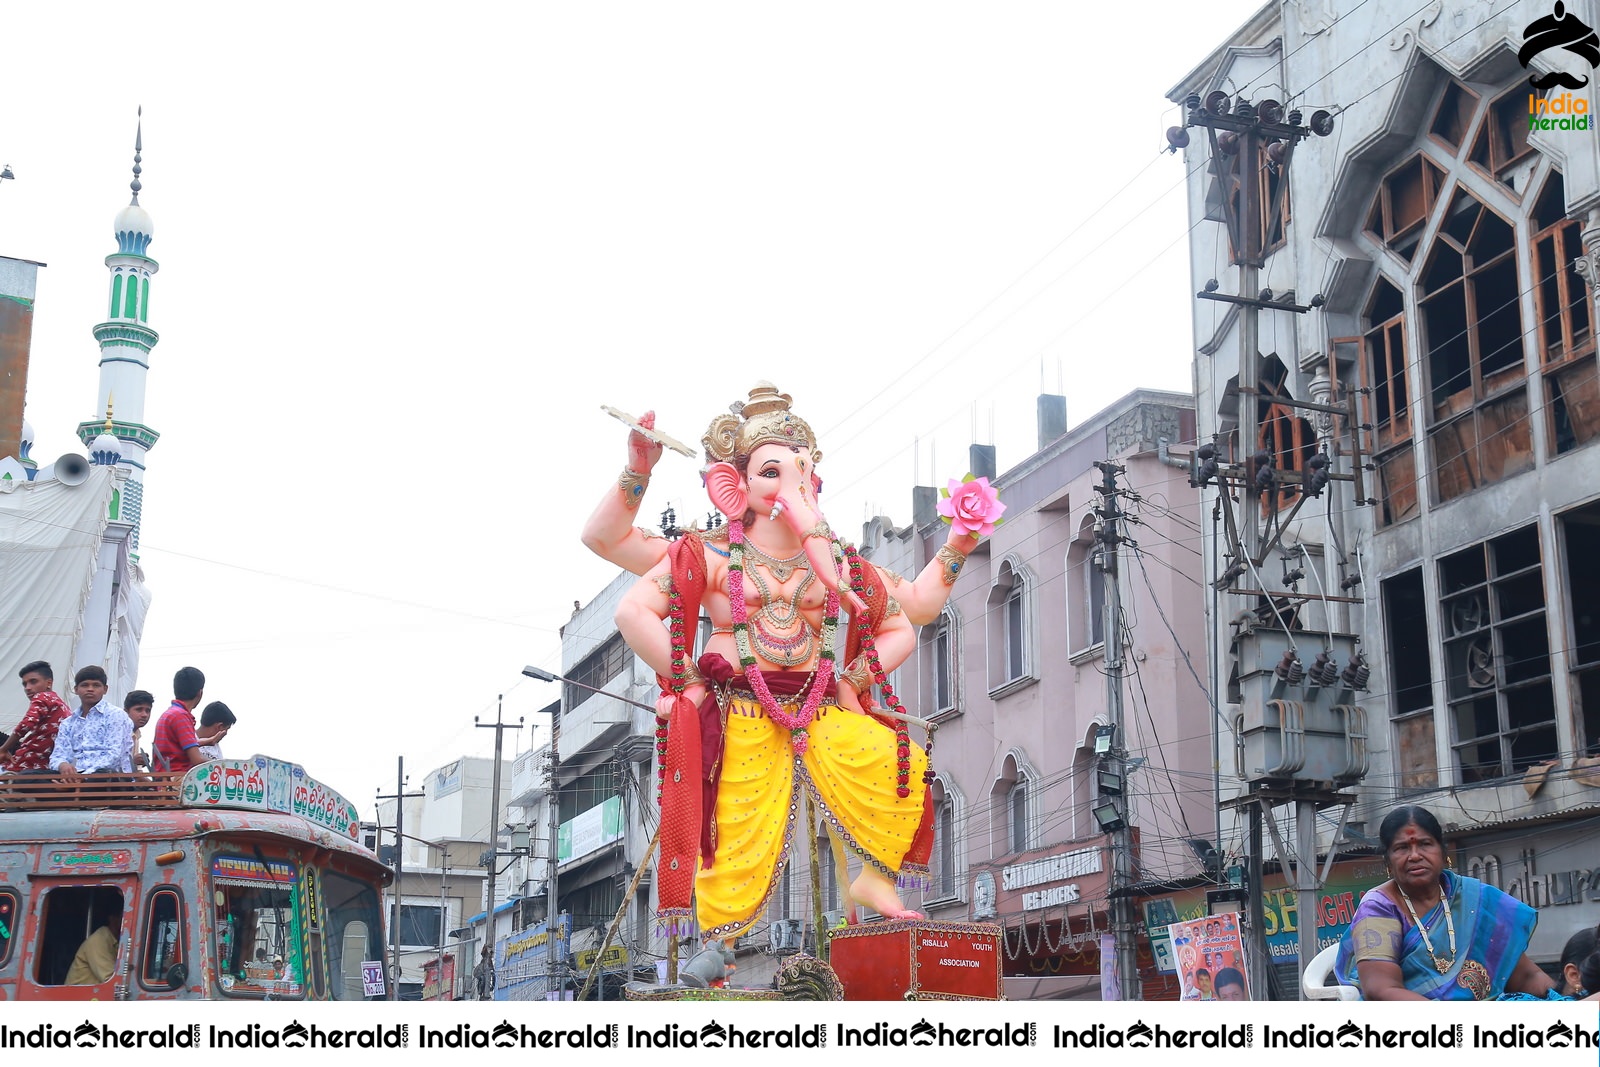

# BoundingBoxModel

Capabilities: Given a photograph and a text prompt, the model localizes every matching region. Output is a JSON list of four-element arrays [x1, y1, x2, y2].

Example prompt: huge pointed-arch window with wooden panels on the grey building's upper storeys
[[1362, 77, 1555, 525]]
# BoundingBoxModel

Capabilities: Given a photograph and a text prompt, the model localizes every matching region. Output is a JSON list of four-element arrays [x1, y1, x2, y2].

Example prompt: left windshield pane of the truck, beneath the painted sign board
[[211, 856, 306, 1000]]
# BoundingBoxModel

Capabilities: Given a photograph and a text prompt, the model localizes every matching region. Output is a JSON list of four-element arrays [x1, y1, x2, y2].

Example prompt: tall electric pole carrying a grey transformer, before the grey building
[[1166, 90, 1376, 998]]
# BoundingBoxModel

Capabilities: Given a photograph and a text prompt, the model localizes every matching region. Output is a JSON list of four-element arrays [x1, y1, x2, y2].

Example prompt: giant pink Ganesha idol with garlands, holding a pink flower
[[584, 382, 1003, 937]]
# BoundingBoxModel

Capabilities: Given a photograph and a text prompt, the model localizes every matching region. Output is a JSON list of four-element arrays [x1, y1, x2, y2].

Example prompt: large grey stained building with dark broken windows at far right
[[1170, 0, 1600, 991]]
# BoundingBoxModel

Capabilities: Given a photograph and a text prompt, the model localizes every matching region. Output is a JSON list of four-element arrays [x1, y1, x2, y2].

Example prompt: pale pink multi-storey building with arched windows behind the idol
[[864, 389, 1216, 1000]]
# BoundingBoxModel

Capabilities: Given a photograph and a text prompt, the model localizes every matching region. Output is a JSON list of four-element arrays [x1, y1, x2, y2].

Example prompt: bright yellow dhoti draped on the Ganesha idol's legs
[[694, 689, 928, 937]]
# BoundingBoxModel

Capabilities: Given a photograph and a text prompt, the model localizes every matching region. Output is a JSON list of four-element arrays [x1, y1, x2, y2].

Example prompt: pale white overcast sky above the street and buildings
[[0, 0, 1259, 817]]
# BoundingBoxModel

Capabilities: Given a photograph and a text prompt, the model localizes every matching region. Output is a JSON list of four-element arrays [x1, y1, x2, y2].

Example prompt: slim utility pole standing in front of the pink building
[[1094, 459, 1139, 1000]]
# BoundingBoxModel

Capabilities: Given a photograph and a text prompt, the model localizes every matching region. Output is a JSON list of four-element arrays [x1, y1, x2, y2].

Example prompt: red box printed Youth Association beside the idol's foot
[[827, 920, 1002, 1000]]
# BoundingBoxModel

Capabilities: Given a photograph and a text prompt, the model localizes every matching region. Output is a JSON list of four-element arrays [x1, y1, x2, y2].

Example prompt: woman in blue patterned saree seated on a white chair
[[1334, 805, 1555, 1000]]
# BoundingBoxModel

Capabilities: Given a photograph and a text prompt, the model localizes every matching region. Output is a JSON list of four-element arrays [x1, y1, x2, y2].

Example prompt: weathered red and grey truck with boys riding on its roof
[[0, 755, 392, 1000]]
